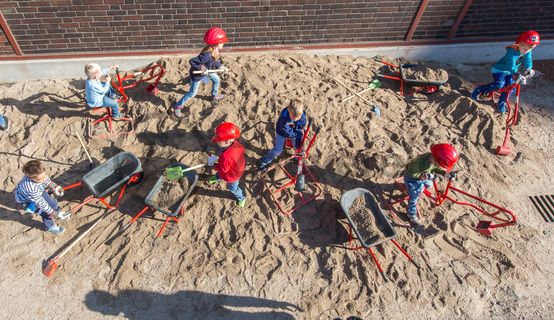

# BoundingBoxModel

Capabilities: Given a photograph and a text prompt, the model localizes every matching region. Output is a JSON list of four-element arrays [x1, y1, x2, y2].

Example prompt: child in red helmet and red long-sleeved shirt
[[208, 122, 246, 208]]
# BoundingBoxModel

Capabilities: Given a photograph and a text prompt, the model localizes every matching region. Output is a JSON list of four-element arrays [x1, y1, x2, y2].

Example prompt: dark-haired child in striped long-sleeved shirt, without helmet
[[14, 160, 71, 234]]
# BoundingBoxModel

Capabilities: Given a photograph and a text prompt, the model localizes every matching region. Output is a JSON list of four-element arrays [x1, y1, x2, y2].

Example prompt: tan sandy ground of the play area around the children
[[0, 54, 554, 319]]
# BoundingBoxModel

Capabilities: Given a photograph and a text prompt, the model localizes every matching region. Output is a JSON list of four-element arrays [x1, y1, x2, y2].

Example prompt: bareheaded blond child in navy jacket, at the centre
[[258, 99, 307, 171]]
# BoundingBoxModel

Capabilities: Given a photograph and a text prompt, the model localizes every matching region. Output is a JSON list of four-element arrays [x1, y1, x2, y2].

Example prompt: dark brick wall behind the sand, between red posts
[[0, 0, 554, 54]]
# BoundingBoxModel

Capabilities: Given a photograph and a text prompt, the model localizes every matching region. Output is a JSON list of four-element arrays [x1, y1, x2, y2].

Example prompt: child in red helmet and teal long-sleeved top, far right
[[471, 30, 540, 113]]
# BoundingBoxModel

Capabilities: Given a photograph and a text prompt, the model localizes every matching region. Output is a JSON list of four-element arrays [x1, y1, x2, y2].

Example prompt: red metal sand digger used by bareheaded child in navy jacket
[[263, 123, 321, 215]]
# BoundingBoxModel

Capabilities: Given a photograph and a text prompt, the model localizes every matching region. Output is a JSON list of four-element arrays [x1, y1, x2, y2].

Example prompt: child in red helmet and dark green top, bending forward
[[404, 143, 460, 225]]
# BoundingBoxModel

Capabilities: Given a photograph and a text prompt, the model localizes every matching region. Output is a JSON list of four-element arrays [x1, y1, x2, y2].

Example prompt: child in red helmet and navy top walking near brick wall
[[173, 27, 228, 118]]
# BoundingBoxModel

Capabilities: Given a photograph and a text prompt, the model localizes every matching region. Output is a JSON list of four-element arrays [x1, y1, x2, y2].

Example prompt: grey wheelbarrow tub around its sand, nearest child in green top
[[340, 188, 396, 249]]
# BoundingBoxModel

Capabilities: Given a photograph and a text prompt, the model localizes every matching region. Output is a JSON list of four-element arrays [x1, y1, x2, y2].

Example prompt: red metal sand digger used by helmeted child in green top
[[387, 178, 517, 236]]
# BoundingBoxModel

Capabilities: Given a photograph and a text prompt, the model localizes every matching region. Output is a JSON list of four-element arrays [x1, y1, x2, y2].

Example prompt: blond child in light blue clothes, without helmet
[[85, 63, 121, 118]]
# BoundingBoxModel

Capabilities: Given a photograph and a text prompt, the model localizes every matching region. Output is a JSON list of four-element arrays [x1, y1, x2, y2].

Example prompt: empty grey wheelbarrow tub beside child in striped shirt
[[83, 152, 142, 198]]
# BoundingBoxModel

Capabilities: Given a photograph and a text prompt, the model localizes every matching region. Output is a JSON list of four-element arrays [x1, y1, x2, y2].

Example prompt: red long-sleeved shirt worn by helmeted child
[[214, 141, 246, 183]]
